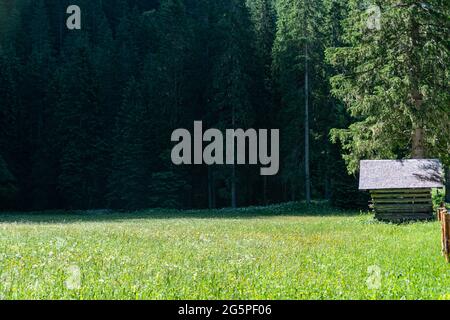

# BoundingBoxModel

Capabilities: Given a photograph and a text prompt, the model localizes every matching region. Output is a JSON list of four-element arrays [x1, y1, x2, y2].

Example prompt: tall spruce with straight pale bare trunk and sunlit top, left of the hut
[[273, 0, 323, 202]]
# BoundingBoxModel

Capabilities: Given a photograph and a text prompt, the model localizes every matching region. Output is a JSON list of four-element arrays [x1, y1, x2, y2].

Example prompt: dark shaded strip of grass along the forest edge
[[0, 201, 366, 224]]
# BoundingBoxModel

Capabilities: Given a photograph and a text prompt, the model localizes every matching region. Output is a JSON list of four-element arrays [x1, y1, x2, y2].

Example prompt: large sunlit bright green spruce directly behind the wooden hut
[[327, 0, 450, 172]]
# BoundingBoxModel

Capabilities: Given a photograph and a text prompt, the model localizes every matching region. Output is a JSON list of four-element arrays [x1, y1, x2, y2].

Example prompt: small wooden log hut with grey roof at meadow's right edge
[[359, 159, 444, 221]]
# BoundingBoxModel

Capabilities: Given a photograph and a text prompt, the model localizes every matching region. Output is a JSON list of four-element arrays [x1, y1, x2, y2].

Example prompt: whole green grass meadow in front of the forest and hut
[[0, 204, 450, 299]]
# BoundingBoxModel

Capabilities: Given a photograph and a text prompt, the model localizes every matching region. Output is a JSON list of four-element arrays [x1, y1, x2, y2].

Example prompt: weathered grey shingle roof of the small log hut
[[359, 159, 444, 190]]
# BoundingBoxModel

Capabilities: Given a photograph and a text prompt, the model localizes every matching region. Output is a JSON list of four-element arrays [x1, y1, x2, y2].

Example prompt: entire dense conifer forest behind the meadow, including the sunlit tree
[[0, 0, 450, 210]]
